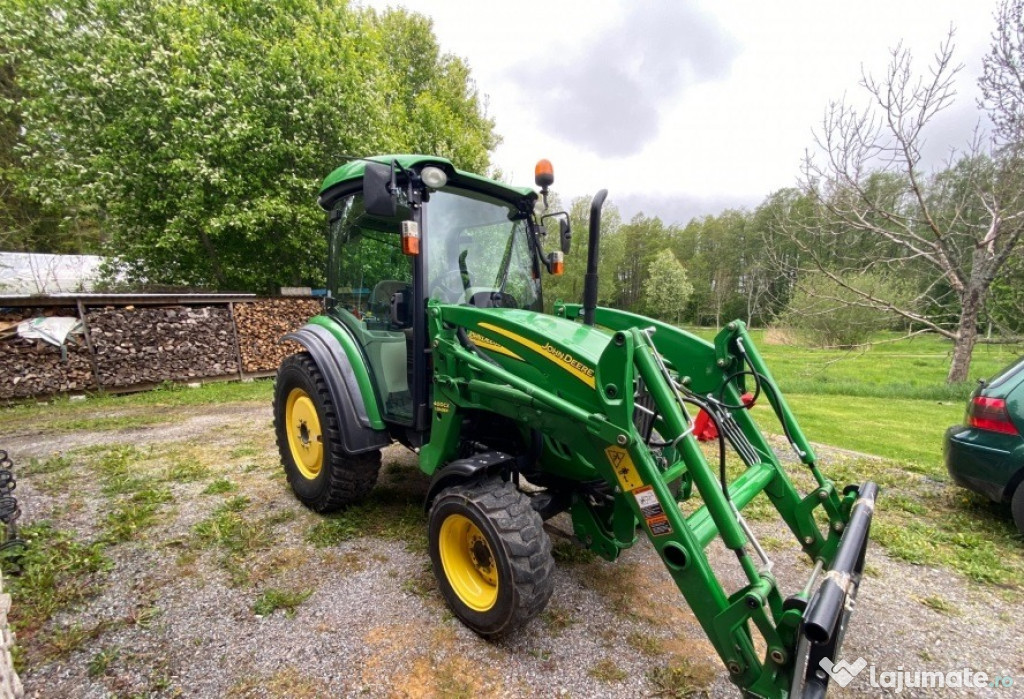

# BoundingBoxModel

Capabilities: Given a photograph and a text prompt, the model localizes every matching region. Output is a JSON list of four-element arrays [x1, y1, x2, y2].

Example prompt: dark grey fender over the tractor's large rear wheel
[[282, 322, 391, 454]]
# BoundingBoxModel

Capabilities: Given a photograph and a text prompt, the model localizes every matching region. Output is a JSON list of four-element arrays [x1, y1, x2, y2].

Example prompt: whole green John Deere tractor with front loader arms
[[273, 155, 878, 697]]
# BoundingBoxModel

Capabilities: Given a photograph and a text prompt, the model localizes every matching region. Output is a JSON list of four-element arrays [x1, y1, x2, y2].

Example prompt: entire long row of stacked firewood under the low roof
[[0, 298, 323, 400]]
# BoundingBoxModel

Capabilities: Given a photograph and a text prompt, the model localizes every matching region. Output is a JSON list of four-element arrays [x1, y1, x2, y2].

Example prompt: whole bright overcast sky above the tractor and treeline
[[364, 0, 996, 223]]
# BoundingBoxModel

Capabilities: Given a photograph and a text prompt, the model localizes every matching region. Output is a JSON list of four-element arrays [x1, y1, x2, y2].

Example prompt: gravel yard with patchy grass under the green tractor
[[0, 403, 1024, 697]]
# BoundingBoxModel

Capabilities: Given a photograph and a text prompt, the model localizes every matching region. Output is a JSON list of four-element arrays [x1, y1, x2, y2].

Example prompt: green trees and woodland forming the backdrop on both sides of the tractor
[[6, 0, 1024, 382]]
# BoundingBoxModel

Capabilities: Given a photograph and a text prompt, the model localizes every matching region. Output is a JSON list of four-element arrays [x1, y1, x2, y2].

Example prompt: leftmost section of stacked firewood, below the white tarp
[[0, 308, 95, 399]]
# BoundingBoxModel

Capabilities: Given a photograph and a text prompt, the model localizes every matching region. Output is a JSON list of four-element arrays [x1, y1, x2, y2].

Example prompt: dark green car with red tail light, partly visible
[[944, 357, 1024, 533]]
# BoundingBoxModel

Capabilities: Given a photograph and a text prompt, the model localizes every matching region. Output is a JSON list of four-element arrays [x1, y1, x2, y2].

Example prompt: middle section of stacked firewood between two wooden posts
[[85, 306, 239, 388]]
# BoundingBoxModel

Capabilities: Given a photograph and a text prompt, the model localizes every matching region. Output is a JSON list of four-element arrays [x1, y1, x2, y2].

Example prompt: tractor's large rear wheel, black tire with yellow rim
[[273, 352, 381, 513]]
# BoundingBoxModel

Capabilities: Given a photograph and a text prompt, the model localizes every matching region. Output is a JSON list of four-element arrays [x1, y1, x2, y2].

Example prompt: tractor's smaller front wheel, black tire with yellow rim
[[428, 478, 555, 639]]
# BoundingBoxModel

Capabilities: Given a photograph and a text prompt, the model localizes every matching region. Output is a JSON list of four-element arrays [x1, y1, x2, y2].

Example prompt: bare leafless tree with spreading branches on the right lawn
[[782, 0, 1024, 382]]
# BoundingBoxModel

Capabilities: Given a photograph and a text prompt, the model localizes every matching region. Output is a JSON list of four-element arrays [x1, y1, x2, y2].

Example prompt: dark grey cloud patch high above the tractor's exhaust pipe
[[509, 2, 738, 157]]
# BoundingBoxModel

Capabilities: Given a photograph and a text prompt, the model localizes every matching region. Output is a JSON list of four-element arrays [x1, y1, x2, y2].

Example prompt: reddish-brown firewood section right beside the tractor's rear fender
[[234, 299, 324, 374]]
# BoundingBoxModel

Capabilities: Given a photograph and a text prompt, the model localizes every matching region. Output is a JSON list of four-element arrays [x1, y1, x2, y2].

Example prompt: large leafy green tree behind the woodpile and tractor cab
[[0, 0, 497, 292]]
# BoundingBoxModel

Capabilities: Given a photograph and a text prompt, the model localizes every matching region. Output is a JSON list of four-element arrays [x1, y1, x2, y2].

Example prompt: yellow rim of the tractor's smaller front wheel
[[438, 515, 498, 612]]
